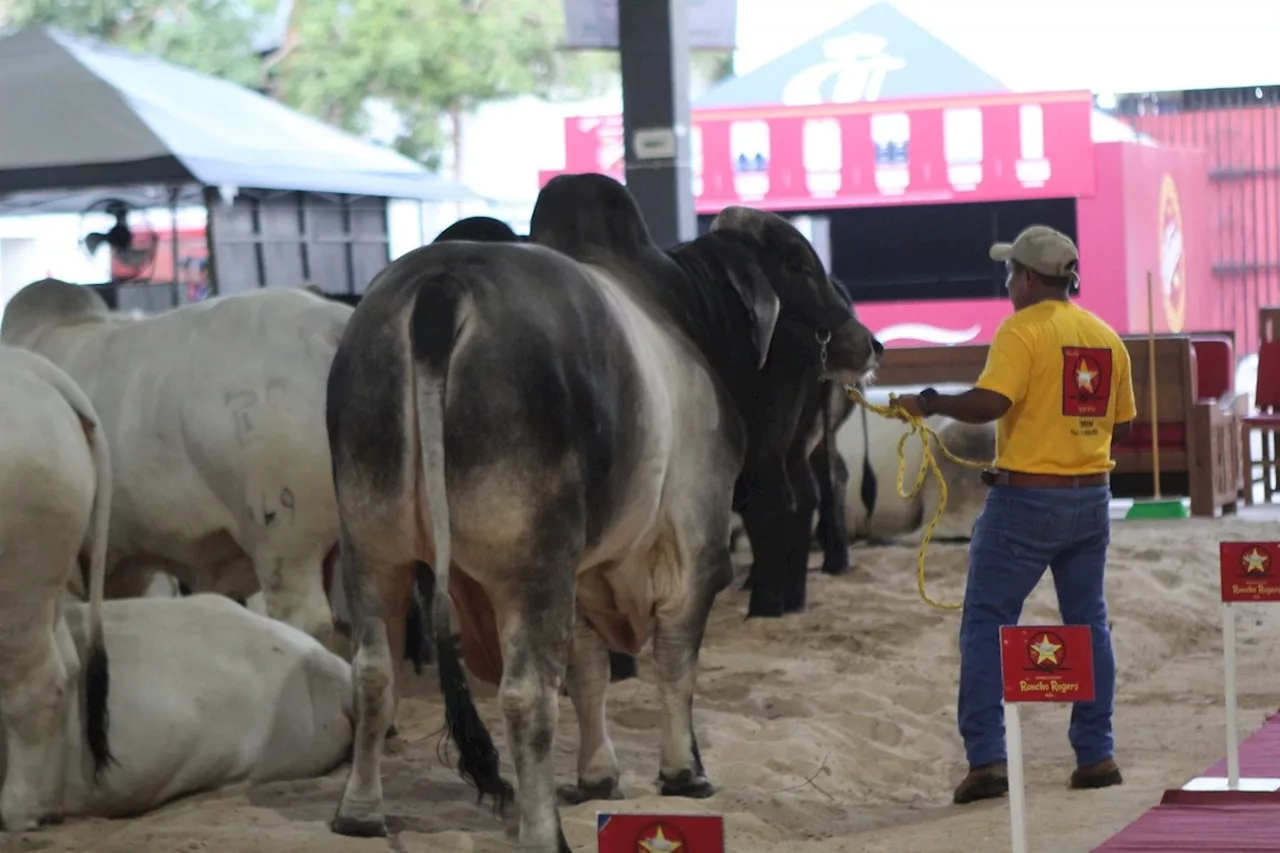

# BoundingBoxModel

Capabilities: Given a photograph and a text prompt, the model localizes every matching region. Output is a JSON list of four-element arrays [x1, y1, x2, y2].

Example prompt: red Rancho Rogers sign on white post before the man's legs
[[1000, 625, 1094, 853]]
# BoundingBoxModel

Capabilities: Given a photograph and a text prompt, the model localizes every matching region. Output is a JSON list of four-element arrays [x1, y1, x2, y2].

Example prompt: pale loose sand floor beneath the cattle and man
[[17, 507, 1280, 853]]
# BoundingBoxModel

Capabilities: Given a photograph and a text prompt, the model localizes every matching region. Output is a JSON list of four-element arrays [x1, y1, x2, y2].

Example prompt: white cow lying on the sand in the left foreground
[[12, 593, 352, 817]]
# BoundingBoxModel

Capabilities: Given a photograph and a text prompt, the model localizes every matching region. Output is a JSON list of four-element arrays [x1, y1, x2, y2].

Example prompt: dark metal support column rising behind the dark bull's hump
[[618, 0, 698, 248]]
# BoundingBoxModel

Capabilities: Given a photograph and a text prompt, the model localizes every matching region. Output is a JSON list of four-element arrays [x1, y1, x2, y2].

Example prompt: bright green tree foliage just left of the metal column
[[271, 0, 617, 164]]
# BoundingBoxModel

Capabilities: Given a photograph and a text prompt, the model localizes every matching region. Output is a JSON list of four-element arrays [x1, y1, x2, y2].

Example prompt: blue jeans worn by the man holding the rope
[[959, 485, 1116, 767]]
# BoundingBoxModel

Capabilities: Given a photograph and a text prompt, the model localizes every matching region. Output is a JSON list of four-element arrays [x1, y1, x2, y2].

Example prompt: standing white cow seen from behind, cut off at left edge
[[0, 346, 111, 831]]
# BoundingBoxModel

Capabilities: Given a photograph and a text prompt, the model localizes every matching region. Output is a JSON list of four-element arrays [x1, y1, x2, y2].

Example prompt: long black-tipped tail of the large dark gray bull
[[410, 280, 512, 812]]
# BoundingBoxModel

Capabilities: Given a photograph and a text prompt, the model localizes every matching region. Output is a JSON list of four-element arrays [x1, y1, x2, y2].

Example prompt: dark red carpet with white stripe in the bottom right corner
[[1093, 715, 1280, 853]]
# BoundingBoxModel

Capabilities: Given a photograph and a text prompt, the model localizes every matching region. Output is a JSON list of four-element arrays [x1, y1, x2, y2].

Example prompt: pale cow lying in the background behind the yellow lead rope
[[836, 389, 996, 542]]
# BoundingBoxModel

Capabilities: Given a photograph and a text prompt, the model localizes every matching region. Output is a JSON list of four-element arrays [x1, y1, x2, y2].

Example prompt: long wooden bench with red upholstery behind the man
[[876, 333, 1248, 516]]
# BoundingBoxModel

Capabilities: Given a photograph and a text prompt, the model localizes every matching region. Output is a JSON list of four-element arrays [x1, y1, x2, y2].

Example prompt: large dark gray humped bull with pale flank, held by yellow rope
[[320, 174, 874, 853]]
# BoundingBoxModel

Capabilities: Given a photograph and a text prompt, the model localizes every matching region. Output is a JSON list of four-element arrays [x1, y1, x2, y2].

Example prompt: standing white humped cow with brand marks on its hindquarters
[[0, 279, 352, 643]]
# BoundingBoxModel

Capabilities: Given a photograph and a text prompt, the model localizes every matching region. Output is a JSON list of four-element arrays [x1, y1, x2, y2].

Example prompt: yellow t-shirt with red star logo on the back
[[974, 300, 1137, 476]]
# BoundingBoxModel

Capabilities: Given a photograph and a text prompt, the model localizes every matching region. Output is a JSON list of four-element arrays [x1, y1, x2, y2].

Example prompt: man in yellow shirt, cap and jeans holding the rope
[[899, 225, 1137, 803]]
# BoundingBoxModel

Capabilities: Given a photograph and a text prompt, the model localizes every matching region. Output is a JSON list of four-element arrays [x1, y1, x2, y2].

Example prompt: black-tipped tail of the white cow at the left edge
[[19, 353, 116, 781]]
